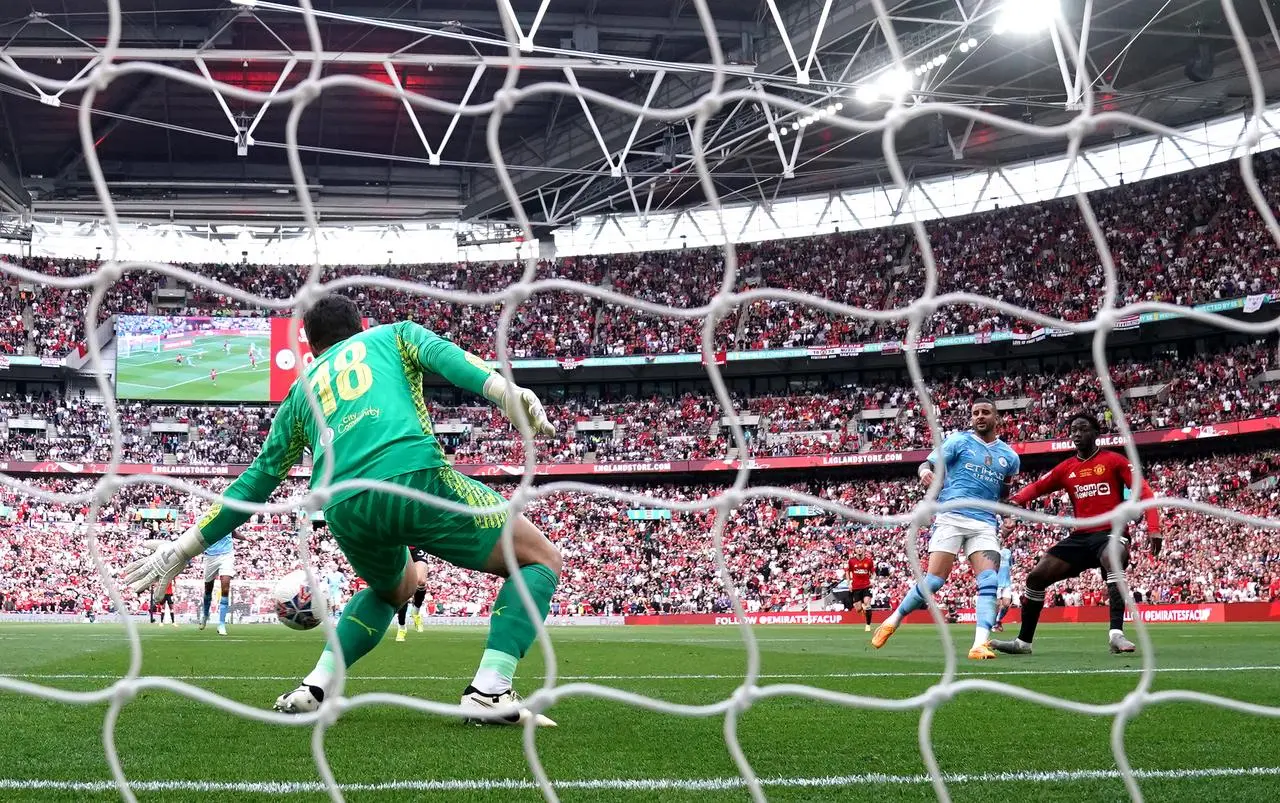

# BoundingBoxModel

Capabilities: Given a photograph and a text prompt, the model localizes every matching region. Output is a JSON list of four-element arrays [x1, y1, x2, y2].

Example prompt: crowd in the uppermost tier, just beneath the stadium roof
[[0, 152, 1280, 359]]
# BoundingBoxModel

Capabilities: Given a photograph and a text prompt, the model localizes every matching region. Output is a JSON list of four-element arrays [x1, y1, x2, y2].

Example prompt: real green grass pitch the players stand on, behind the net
[[0, 624, 1280, 802]]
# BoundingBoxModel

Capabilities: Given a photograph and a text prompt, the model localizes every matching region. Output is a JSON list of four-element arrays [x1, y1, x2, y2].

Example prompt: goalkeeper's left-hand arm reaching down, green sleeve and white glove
[[124, 393, 310, 592]]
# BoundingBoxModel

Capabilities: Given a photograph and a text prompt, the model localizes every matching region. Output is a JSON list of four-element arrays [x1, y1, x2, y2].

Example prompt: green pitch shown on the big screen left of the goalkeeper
[[115, 333, 271, 402]]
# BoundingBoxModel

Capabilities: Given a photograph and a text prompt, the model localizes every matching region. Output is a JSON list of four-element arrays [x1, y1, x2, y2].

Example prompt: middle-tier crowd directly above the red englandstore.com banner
[[0, 341, 1280, 465]]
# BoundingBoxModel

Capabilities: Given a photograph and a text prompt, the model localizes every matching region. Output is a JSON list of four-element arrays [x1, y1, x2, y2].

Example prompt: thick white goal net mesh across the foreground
[[0, 0, 1280, 800]]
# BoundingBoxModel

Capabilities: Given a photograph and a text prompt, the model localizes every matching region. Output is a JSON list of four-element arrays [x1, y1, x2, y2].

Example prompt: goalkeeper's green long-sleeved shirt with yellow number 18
[[200, 321, 493, 543]]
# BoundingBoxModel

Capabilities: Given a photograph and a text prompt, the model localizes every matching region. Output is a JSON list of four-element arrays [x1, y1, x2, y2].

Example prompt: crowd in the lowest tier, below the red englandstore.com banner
[[0, 452, 1280, 615]]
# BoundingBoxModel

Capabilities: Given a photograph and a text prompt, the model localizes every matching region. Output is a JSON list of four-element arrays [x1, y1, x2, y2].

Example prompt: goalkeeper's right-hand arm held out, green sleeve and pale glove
[[396, 320, 556, 435]]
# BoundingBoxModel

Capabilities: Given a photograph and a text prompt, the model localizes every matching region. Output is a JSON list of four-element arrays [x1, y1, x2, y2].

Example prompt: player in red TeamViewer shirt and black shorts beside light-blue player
[[991, 412, 1162, 656]]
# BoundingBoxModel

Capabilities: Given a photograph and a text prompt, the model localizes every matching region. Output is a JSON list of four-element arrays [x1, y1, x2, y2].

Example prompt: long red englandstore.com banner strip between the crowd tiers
[[0, 420, 1280, 478]]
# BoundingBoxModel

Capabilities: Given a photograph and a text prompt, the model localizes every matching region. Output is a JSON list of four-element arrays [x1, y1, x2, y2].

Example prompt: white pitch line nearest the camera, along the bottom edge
[[0, 767, 1280, 795]]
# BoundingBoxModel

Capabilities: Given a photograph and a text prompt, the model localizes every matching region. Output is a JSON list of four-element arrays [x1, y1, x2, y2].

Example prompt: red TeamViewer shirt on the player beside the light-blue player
[[1010, 450, 1160, 535]]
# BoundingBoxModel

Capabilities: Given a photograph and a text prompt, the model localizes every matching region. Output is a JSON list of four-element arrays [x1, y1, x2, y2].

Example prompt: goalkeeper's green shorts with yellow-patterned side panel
[[324, 466, 507, 590]]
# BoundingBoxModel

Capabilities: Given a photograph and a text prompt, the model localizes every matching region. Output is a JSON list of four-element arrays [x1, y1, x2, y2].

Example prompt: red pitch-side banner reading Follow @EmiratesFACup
[[626, 602, 1280, 626]]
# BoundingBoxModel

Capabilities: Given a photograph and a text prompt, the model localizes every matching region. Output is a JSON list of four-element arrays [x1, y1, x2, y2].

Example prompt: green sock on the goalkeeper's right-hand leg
[[472, 564, 559, 692]]
